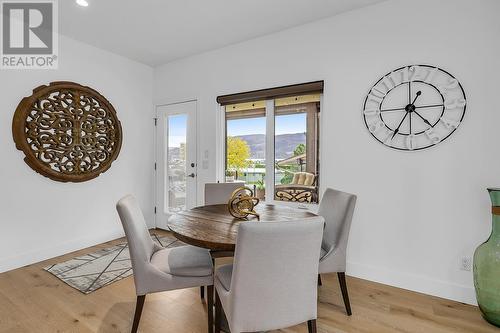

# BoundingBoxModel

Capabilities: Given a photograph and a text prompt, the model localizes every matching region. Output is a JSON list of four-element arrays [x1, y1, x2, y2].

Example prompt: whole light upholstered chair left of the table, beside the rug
[[116, 195, 213, 333]]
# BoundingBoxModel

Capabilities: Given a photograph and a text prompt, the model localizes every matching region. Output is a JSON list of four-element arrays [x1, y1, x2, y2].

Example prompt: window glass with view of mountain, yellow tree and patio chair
[[226, 95, 319, 202]]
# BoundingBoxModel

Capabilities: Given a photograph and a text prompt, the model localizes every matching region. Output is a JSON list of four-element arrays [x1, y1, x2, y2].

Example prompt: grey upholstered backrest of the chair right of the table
[[318, 188, 356, 251]]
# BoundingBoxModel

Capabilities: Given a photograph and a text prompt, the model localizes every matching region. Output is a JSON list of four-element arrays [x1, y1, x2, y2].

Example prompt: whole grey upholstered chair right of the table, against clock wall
[[318, 188, 356, 316]]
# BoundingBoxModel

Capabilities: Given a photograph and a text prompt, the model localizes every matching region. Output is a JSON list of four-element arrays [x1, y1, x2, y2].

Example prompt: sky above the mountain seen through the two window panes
[[227, 113, 306, 136]]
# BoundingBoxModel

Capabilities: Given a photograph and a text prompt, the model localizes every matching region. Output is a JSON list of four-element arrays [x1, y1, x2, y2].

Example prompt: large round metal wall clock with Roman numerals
[[363, 65, 467, 151]]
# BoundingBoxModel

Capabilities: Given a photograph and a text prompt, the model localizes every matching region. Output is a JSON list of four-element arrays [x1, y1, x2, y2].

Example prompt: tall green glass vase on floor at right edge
[[474, 188, 500, 327]]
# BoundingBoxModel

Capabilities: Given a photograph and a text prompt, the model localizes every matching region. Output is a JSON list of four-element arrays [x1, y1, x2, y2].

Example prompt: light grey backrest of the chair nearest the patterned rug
[[116, 194, 154, 278]]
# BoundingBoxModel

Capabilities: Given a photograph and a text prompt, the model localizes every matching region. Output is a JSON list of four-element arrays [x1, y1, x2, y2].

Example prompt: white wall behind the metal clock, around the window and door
[[154, 0, 500, 303]]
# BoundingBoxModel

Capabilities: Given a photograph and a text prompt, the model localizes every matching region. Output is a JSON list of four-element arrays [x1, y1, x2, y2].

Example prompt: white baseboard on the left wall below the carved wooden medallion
[[0, 228, 124, 273]]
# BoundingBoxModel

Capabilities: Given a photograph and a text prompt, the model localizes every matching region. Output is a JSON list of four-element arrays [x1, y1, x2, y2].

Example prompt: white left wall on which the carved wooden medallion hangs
[[0, 37, 154, 271]]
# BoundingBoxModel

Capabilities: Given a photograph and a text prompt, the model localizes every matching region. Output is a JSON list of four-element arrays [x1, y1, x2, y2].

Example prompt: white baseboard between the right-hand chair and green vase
[[346, 262, 477, 305]]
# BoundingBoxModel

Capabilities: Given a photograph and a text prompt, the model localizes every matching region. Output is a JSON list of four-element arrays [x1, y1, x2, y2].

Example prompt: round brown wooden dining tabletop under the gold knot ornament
[[167, 204, 316, 252]]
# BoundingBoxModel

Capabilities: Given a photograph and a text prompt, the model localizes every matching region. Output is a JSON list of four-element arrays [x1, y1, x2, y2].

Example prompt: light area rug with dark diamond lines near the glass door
[[44, 234, 185, 294]]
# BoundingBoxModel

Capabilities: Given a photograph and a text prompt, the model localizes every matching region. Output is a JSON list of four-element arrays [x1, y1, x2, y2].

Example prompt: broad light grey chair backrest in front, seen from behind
[[230, 216, 324, 332]]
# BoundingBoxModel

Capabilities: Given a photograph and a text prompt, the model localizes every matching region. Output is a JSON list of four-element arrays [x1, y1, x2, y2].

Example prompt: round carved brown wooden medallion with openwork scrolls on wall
[[12, 82, 122, 182]]
